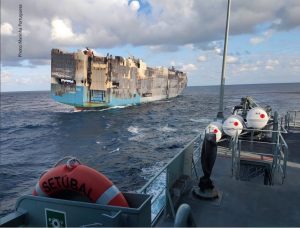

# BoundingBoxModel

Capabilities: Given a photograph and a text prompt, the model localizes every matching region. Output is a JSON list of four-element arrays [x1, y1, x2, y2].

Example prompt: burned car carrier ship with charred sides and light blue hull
[[51, 48, 187, 109]]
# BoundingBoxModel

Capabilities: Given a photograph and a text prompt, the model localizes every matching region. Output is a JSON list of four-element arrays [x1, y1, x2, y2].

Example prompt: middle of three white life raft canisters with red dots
[[223, 115, 245, 137]]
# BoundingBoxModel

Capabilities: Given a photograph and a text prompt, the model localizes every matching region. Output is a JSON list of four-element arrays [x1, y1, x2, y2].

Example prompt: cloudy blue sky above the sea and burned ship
[[1, 0, 300, 92]]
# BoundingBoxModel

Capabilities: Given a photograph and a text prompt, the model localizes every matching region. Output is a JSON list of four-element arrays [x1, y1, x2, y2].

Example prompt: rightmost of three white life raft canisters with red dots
[[246, 107, 269, 129]]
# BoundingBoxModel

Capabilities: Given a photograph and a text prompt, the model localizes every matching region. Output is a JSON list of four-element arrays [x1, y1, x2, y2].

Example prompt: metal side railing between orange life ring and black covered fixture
[[138, 134, 202, 225]]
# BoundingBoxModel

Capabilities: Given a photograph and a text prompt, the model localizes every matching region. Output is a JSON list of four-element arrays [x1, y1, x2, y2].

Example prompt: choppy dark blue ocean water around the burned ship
[[0, 83, 300, 216]]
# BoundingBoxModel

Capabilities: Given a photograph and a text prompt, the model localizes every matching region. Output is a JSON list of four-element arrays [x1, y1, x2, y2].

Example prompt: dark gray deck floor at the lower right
[[157, 128, 300, 226]]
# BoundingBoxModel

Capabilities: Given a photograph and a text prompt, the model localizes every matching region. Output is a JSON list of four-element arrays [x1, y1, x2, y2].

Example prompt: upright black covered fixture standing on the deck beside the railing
[[198, 133, 217, 192]]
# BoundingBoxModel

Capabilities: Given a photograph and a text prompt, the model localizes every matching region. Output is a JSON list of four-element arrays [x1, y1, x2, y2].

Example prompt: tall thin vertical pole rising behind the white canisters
[[217, 0, 231, 119]]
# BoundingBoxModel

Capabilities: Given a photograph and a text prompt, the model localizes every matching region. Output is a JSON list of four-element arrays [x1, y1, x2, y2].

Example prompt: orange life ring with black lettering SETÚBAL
[[33, 158, 129, 207]]
